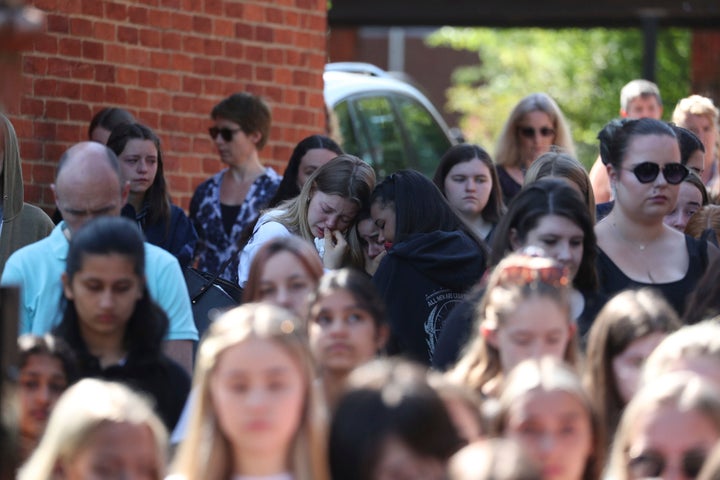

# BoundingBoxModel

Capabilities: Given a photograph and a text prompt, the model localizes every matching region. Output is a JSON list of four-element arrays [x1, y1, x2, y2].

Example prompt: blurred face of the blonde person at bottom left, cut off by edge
[[55, 422, 163, 480]]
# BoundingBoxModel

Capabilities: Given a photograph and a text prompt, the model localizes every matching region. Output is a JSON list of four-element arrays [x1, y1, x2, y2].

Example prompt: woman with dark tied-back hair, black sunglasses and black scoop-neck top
[[595, 118, 717, 316]]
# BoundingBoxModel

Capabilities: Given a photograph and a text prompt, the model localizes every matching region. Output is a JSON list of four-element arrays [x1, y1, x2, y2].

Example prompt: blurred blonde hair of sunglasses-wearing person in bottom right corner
[[605, 373, 720, 480]]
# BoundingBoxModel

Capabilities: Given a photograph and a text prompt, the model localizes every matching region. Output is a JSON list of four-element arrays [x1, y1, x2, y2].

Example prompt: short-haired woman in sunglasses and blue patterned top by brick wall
[[190, 93, 281, 280]]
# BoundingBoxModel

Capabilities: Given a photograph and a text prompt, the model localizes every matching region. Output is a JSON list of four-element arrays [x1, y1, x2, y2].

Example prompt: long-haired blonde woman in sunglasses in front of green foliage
[[495, 93, 575, 205]]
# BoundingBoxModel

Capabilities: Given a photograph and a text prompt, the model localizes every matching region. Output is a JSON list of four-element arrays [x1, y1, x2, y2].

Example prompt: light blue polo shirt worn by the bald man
[[0, 222, 198, 340]]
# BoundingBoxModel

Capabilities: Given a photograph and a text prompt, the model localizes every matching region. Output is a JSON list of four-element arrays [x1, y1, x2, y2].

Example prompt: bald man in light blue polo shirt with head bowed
[[0, 142, 198, 371]]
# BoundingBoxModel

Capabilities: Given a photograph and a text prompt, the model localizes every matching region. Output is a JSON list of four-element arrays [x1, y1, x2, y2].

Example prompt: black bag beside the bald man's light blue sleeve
[[183, 261, 242, 338]]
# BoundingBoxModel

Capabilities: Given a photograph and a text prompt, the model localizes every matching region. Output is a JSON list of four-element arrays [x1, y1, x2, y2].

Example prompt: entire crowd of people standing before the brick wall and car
[[0, 80, 720, 480]]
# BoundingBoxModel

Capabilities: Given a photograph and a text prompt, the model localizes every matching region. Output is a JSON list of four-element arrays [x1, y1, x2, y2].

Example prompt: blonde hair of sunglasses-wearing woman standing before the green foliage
[[495, 93, 575, 167]]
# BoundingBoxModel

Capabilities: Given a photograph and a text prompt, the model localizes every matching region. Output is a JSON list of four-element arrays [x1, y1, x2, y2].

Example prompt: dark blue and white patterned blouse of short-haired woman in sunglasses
[[190, 167, 282, 280]]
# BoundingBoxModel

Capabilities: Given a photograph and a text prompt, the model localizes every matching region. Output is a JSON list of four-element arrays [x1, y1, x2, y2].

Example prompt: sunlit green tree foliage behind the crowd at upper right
[[427, 27, 690, 166]]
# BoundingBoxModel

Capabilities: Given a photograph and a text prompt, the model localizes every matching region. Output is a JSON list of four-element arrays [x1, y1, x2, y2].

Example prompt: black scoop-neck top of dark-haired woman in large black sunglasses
[[597, 235, 708, 317]]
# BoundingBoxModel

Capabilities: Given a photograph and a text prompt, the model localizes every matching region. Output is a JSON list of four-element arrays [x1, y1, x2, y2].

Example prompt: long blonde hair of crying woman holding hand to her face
[[275, 154, 375, 242]]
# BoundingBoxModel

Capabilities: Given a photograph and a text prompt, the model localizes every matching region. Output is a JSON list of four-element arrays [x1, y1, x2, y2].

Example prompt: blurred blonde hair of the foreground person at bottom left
[[18, 378, 167, 480]]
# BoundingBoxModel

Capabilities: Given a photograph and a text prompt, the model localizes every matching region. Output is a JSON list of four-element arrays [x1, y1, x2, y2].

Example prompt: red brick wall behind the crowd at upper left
[[6, 0, 327, 210]]
